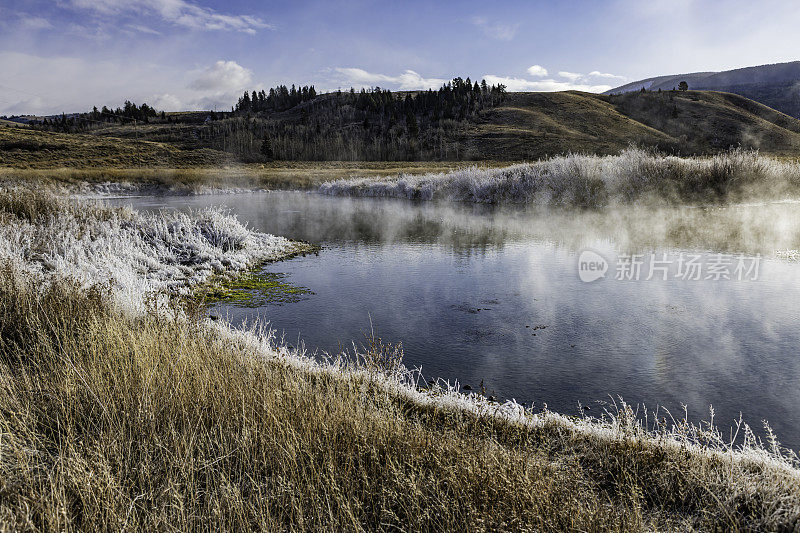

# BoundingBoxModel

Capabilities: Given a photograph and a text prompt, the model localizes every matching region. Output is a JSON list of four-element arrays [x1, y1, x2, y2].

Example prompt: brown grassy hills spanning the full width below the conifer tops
[[6, 91, 800, 166]]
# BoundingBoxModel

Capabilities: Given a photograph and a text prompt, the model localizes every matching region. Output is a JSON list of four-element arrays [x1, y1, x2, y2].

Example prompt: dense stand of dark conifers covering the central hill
[[223, 77, 506, 161]]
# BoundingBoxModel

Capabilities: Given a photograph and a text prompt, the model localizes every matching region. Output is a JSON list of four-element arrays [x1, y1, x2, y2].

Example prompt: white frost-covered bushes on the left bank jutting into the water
[[0, 191, 295, 310]]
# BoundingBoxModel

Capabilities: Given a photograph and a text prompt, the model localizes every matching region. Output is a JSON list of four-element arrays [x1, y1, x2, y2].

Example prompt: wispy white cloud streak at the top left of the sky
[[71, 0, 273, 34]]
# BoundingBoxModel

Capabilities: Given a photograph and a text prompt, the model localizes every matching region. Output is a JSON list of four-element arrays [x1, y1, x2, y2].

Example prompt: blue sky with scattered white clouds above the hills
[[0, 0, 800, 115]]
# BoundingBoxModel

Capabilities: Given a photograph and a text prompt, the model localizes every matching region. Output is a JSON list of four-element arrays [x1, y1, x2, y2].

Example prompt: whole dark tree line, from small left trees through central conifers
[[28, 77, 506, 162]]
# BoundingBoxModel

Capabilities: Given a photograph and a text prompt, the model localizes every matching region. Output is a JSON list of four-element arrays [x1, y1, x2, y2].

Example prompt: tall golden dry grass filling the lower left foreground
[[0, 271, 630, 530]]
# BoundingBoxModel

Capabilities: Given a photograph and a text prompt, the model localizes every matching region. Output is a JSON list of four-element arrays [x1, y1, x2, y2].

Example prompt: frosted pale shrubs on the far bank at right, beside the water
[[319, 148, 800, 206]]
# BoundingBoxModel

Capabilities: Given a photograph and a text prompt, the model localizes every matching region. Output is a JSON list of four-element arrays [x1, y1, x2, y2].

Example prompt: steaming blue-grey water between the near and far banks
[[114, 192, 800, 450]]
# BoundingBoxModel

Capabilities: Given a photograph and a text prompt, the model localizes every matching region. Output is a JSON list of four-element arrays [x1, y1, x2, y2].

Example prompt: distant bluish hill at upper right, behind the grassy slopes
[[606, 61, 800, 118]]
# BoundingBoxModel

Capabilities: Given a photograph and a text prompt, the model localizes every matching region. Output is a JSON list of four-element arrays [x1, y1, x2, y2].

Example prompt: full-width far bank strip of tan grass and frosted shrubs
[[6, 147, 800, 207]]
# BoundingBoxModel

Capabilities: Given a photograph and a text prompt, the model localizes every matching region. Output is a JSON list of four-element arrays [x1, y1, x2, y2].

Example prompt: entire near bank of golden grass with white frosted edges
[[0, 192, 800, 531]]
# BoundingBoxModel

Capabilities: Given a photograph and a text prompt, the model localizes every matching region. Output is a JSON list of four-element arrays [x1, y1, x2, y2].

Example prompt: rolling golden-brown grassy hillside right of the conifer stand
[[434, 91, 800, 160]]
